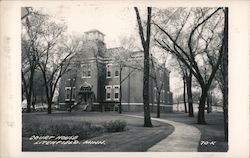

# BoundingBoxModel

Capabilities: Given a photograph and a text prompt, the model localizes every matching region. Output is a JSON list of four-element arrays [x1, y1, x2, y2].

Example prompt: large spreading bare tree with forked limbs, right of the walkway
[[154, 8, 225, 124]]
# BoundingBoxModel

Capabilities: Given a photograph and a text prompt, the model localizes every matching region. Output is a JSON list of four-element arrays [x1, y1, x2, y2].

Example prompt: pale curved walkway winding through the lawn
[[123, 115, 201, 152]]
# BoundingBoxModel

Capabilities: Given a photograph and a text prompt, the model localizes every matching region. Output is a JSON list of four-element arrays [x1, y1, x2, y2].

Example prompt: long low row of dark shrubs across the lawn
[[23, 120, 127, 140]]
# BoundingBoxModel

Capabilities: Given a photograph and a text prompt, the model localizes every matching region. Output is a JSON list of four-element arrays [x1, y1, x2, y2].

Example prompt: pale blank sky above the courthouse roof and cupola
[[43, 6, 182, 95]]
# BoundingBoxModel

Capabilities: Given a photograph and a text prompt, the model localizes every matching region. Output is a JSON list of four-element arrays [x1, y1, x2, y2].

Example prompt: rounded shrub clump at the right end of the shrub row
[[103, 120, 127, 132]]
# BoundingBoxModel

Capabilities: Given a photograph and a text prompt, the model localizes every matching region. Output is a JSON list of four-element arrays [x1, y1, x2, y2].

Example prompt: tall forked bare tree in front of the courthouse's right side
[[134, 7, 152, 127]]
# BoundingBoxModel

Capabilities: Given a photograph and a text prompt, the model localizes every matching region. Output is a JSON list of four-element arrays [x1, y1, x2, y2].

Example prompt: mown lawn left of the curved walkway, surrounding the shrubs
[[22, 112, 174, 152]]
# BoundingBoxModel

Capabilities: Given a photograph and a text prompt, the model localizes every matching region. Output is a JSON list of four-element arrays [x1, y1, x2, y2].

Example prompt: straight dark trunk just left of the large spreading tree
[[187, 71, 194, 117]]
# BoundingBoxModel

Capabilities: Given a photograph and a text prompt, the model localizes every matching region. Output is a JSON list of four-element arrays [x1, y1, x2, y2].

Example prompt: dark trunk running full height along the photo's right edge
[[222, 7, 228, 141]]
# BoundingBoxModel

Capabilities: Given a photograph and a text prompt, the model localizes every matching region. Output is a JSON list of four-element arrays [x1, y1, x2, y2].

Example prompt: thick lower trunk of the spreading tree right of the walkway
[[198, 86, 207, 124]]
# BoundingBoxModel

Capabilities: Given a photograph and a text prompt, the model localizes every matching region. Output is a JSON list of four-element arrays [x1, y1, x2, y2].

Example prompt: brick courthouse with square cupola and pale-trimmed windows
[[59, 30, 172, 112]]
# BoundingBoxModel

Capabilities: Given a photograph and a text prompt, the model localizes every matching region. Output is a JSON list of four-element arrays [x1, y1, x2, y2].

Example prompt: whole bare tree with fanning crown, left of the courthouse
[[22, 8, 81, 113]]
